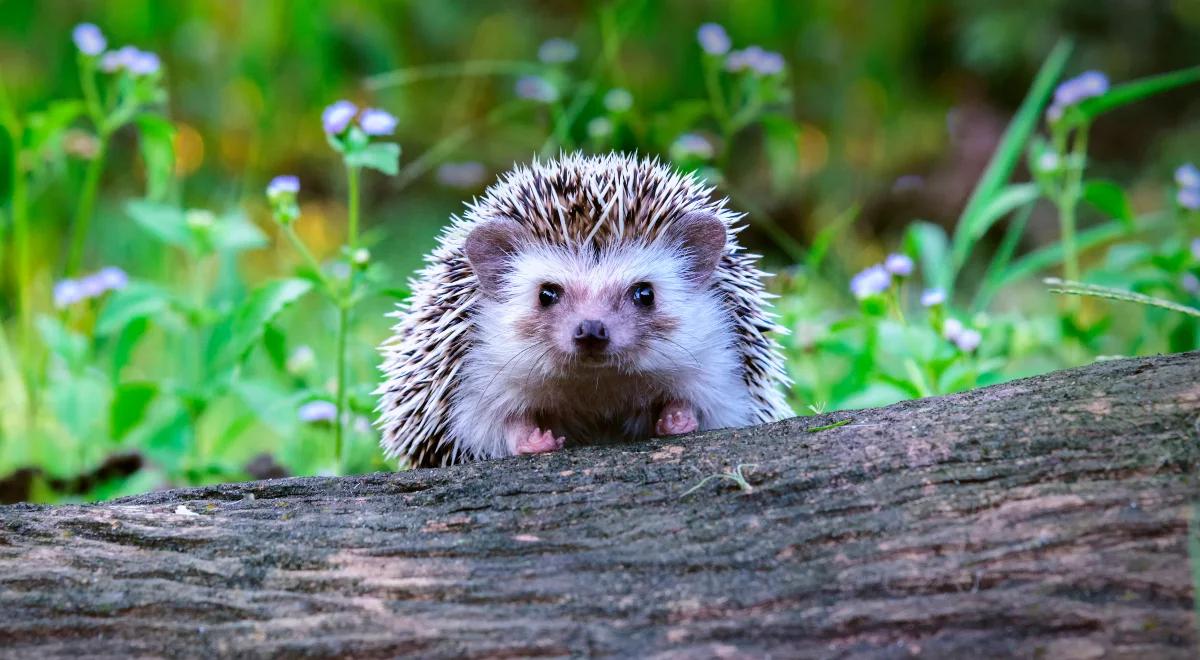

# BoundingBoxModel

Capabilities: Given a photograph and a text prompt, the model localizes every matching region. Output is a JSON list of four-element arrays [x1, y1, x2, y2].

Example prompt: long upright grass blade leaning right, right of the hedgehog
[[934, 40, 1072, 295]]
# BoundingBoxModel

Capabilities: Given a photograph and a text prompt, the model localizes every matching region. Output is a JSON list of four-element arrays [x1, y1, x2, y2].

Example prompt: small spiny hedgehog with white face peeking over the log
[[376, 152, 792, 467]]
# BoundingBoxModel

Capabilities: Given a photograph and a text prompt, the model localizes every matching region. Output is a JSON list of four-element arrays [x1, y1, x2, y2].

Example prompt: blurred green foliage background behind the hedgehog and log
[[0, 0, 1200, 499]]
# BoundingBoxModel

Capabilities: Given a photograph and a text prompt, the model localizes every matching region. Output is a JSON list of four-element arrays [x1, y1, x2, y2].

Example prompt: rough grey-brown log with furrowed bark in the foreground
[[0, 353, 1200, 658]]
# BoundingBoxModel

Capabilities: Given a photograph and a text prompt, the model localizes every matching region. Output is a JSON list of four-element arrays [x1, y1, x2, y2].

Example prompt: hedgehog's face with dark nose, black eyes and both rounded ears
[[464, 215, 725, 374]]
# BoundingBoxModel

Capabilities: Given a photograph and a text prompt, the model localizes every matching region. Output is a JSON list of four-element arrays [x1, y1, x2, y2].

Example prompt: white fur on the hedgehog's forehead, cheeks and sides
[[450, 241, 752, 458]]
